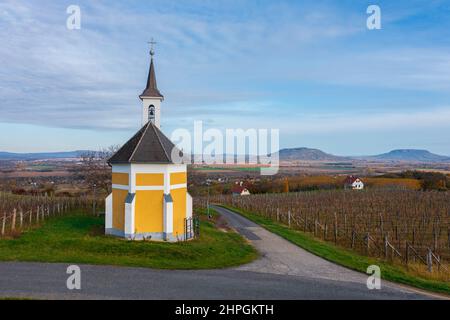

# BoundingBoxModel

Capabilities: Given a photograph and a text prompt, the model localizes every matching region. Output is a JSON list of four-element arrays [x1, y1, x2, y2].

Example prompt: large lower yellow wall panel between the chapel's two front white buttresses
[[135, 190, 164, 233]]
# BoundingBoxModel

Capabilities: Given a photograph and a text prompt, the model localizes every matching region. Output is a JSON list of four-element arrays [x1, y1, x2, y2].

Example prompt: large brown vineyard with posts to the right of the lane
[[200, 189, 450, 274]]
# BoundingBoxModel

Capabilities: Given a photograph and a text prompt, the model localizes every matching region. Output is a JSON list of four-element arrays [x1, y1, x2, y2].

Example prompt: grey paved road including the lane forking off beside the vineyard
[[0, 208, 438, 300]]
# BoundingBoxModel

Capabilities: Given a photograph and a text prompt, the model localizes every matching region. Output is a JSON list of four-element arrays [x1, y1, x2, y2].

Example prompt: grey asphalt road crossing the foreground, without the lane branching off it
[[0, 262, 430, 300]]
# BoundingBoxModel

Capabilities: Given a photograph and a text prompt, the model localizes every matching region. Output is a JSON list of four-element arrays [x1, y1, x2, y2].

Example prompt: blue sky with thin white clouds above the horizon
[[0, 0, 450, 155]]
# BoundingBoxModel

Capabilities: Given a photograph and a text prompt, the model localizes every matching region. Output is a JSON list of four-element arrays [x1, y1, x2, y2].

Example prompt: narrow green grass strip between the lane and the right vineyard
[[223, 206, 450, 295]]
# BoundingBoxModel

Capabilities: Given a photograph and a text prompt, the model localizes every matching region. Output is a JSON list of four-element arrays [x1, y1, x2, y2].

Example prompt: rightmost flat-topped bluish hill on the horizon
[[368, 149, 450, 162]]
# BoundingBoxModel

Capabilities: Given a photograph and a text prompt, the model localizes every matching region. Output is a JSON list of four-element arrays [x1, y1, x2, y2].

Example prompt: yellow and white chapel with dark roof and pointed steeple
[[105, 49, 193, 242]]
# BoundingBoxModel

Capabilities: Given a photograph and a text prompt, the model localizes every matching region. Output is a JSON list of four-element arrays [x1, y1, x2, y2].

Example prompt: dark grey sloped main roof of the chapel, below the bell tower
[[108, 121, 183, 164]]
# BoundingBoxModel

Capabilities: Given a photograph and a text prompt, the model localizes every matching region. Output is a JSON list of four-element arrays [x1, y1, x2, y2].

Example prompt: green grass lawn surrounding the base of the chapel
[[0, 213, 258, 269]]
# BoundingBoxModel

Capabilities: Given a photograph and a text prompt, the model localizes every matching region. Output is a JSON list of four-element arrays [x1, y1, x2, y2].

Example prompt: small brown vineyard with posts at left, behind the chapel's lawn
[[0, 192, 93, 237]]
